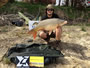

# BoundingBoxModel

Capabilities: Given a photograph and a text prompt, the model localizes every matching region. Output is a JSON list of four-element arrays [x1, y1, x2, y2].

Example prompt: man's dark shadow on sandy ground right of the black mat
[[61, 42, 90, 60]]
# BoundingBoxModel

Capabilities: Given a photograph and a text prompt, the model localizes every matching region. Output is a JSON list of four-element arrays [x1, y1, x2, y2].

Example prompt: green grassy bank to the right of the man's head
[[55, 6, 90, 19]]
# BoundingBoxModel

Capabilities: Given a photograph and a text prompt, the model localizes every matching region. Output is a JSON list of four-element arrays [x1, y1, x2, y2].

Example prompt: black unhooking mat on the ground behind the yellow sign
[[6, 43, 63, 64]]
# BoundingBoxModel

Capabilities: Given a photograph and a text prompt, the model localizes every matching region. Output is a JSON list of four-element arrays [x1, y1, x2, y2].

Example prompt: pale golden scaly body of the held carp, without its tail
[[35, 18, 64, 30]]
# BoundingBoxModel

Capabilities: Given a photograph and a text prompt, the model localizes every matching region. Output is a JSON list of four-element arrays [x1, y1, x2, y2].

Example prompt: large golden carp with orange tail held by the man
[[28, 18, 67, 40]]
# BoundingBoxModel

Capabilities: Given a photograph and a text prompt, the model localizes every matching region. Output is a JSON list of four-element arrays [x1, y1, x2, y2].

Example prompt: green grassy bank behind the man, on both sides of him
[[0, 2, 90, 23]]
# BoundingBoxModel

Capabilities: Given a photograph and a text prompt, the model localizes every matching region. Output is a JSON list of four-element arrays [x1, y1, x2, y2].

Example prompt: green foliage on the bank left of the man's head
[[0, 2, 45, 15]]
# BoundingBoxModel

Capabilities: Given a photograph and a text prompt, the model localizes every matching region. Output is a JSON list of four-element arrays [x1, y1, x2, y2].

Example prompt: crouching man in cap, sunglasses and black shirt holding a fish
[[39, 4, 62, 44]]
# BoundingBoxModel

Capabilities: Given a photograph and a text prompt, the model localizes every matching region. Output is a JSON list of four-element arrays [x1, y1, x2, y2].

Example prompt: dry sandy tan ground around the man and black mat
[[0, 26, 90, 68]]
